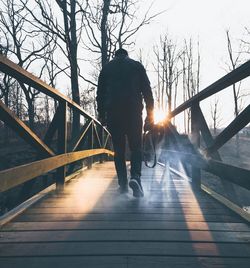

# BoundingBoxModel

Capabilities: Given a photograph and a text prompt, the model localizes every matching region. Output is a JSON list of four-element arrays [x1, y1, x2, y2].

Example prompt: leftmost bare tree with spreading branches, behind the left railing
[[0, 0, 52, 128]]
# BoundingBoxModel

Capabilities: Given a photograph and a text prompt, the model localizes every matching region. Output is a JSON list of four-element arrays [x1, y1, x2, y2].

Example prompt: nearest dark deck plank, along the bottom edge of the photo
[[0, 256, 250, 268]]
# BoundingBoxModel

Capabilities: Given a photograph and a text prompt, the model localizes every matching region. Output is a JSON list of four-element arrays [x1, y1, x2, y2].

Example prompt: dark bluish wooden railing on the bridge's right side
[[163, 61, 250, 219]]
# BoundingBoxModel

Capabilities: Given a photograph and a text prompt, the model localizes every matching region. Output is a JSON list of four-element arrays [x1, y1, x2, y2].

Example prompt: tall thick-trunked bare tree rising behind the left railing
[[21, 0, 91, 135]]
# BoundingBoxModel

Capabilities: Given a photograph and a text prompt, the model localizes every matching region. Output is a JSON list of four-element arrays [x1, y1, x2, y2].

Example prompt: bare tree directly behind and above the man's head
[[83, 0, 161, 68]]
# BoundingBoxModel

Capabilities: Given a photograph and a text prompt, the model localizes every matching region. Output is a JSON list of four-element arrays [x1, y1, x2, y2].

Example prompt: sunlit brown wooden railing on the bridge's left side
[[0, 55, 113, 197]]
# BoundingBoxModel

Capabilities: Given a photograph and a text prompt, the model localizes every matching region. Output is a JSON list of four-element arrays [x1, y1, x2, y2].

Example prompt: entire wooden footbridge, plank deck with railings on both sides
[[0, 56, 250, 268]]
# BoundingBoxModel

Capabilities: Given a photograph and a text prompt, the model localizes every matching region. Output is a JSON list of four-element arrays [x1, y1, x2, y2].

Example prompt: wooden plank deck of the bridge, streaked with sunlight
[[0, 162, 250, 268]]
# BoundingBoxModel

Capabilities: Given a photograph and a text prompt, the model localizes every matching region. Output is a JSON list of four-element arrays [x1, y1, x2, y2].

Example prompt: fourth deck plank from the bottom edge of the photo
[[1, 220, 250, 233]]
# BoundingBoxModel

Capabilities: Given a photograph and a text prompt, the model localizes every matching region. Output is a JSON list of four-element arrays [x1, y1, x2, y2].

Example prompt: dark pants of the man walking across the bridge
[[107, 110, 142, 186]]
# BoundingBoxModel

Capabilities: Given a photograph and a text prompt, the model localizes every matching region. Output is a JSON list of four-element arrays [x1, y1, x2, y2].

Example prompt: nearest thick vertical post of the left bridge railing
[[56, 101, 67, 191]]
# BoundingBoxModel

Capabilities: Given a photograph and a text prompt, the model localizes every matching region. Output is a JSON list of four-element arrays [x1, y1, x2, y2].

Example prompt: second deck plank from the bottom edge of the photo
[[0, 241, 250, 258]]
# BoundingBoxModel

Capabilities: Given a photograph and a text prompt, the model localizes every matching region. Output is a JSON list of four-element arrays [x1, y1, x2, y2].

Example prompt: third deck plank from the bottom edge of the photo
[[1, 229, 250, 243]]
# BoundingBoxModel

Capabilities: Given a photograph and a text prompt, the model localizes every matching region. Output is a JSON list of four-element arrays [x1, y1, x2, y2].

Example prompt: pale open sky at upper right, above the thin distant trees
[[131, 0, 250, 127]]
